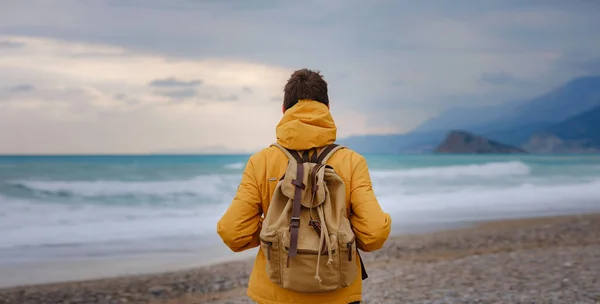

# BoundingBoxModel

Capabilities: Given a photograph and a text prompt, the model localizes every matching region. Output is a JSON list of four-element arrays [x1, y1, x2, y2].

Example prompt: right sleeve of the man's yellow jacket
[[350, 156, 392, 252]]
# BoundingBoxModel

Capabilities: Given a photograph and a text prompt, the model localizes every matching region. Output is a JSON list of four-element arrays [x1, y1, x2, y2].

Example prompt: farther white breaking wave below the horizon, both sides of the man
[[2, 161, 531, 204]]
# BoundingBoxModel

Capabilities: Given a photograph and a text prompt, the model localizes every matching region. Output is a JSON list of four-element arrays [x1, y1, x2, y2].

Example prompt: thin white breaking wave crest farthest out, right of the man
[[371, 161, 531, 179]]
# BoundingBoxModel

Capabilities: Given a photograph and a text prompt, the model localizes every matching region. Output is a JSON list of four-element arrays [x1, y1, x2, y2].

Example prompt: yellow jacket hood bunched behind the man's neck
[[276, 100, 337, 150]]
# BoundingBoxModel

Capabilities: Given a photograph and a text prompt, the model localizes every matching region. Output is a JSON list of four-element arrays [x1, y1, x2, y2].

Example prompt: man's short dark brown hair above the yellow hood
[[283, 69, 329, 110]]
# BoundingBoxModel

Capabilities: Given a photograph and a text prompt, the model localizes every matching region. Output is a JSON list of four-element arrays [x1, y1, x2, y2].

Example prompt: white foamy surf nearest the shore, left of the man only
[[0, 195, 227, 249]]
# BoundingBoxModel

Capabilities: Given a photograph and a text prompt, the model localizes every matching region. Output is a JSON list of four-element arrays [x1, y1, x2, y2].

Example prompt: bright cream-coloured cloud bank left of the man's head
[[0, 36, 291, 153]]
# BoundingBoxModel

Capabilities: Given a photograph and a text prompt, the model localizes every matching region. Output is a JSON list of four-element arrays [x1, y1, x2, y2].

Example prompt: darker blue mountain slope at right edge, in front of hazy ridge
[[524, 106, 600, 153]]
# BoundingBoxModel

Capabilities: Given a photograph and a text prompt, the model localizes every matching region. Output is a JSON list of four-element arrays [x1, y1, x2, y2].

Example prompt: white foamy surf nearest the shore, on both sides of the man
[[0, 180, 600, 248]]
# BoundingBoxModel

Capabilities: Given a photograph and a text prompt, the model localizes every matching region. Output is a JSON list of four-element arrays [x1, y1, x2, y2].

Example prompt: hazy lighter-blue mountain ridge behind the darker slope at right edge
[[340, 76, 600, 153]]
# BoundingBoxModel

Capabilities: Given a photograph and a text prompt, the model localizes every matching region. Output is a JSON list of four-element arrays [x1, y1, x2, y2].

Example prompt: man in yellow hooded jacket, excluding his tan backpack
[[217, 69, 391, 304]]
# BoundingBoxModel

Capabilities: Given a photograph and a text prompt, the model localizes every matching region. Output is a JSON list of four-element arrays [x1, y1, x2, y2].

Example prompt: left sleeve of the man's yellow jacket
[[217, 158, 262, 252]]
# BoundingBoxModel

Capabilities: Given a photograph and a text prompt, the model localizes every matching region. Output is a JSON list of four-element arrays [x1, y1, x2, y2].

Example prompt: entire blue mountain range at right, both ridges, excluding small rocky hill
[[339, 76, 600, 153]]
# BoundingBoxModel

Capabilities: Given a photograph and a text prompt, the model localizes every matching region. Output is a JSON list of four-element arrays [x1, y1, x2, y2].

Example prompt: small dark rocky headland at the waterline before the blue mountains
[[435, 131, 526, 154]]
